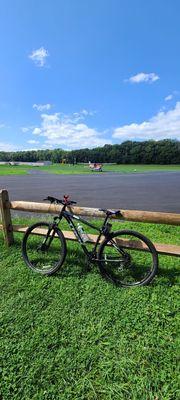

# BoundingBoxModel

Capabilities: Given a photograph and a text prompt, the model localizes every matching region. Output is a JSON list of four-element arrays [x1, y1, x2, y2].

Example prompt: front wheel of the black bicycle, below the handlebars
[[22, 222, 67, 275]]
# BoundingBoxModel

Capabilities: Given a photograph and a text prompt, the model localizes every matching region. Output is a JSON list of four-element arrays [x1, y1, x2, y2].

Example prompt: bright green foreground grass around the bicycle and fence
[[0, 217, 179, 400]]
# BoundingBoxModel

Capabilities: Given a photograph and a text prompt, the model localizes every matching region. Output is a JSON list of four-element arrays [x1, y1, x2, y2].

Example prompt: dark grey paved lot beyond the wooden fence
[[0, 171, 180, 212]]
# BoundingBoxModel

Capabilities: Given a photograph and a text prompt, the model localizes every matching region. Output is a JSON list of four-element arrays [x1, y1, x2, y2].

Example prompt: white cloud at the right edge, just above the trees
[[112, 102, 180, 142]]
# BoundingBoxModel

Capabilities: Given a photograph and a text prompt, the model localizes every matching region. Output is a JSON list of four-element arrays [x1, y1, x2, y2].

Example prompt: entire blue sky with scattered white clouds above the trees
[[0, 0, 180, 151]]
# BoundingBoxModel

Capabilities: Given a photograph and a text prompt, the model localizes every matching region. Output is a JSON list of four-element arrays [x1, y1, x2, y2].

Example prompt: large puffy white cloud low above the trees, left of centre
[[33, 112, 111, 149]]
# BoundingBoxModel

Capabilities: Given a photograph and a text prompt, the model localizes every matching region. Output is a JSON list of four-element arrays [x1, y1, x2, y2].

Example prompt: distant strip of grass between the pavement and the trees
[[0, 164, 180, 175]]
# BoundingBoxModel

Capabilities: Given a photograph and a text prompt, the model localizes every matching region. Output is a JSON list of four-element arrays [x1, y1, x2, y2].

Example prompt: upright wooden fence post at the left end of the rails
[[0, 189, 14, 246]]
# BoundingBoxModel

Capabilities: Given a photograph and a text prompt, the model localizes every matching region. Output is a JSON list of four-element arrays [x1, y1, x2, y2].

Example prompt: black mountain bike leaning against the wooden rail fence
[[22, 195, 158, 287]]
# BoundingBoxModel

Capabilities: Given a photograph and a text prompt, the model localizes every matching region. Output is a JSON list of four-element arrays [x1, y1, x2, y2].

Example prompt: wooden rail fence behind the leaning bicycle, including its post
[[0, 189, 180, 256]]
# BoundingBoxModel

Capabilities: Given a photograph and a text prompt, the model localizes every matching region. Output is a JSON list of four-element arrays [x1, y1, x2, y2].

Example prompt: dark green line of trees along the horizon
[[0, 139, 180, 164]]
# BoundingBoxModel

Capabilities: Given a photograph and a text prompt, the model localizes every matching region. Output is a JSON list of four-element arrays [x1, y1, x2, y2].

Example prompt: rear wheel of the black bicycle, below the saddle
[[98, 230, 158, 287]]
